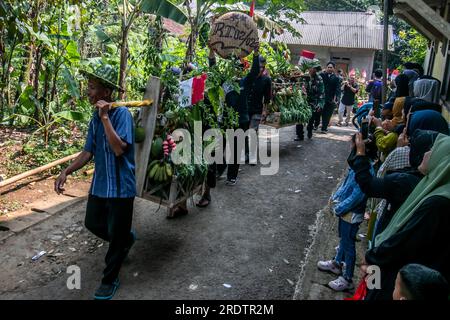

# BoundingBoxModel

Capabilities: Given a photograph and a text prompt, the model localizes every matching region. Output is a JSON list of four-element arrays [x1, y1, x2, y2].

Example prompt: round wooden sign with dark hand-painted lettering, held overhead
[[209, 12, 259, 59]]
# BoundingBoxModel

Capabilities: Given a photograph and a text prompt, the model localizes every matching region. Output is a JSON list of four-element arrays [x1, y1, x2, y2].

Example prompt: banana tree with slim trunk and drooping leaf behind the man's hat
[[119, 0, 187, 99]]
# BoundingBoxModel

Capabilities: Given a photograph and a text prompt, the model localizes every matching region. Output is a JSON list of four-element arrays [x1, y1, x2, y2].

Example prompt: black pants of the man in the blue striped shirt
[[84, 195, 134, 284]]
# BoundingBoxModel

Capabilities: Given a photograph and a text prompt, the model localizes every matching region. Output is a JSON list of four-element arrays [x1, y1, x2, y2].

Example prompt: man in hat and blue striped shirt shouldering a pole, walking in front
[[55, 65, 136, 300]]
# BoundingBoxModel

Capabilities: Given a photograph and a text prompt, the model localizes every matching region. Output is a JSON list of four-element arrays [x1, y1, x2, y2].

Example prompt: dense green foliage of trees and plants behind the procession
[[0, 0, 426, 174]]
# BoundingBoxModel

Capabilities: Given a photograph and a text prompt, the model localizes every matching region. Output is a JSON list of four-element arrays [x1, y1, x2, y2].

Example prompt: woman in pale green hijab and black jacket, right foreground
[[356, 134, 450, 300]]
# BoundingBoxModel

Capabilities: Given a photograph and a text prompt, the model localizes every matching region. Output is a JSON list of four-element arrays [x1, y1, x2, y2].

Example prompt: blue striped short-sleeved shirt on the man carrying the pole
[[84, 107, 136, 198]]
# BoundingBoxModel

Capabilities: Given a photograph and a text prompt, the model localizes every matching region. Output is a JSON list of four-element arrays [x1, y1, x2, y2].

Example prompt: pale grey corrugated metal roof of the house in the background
[[264, 11, 393, 50]]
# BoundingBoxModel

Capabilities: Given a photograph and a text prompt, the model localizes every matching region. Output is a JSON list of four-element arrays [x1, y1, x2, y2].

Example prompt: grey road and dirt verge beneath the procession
[[0, 118, 352, 299]]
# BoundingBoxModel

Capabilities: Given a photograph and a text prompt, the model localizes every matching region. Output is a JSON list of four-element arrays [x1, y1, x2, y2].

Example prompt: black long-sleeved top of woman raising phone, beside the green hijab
[[349, 156, 423, 232]]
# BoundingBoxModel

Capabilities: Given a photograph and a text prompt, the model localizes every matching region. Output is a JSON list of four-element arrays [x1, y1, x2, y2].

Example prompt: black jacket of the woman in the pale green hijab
[[366, 196, 450, 300]]
